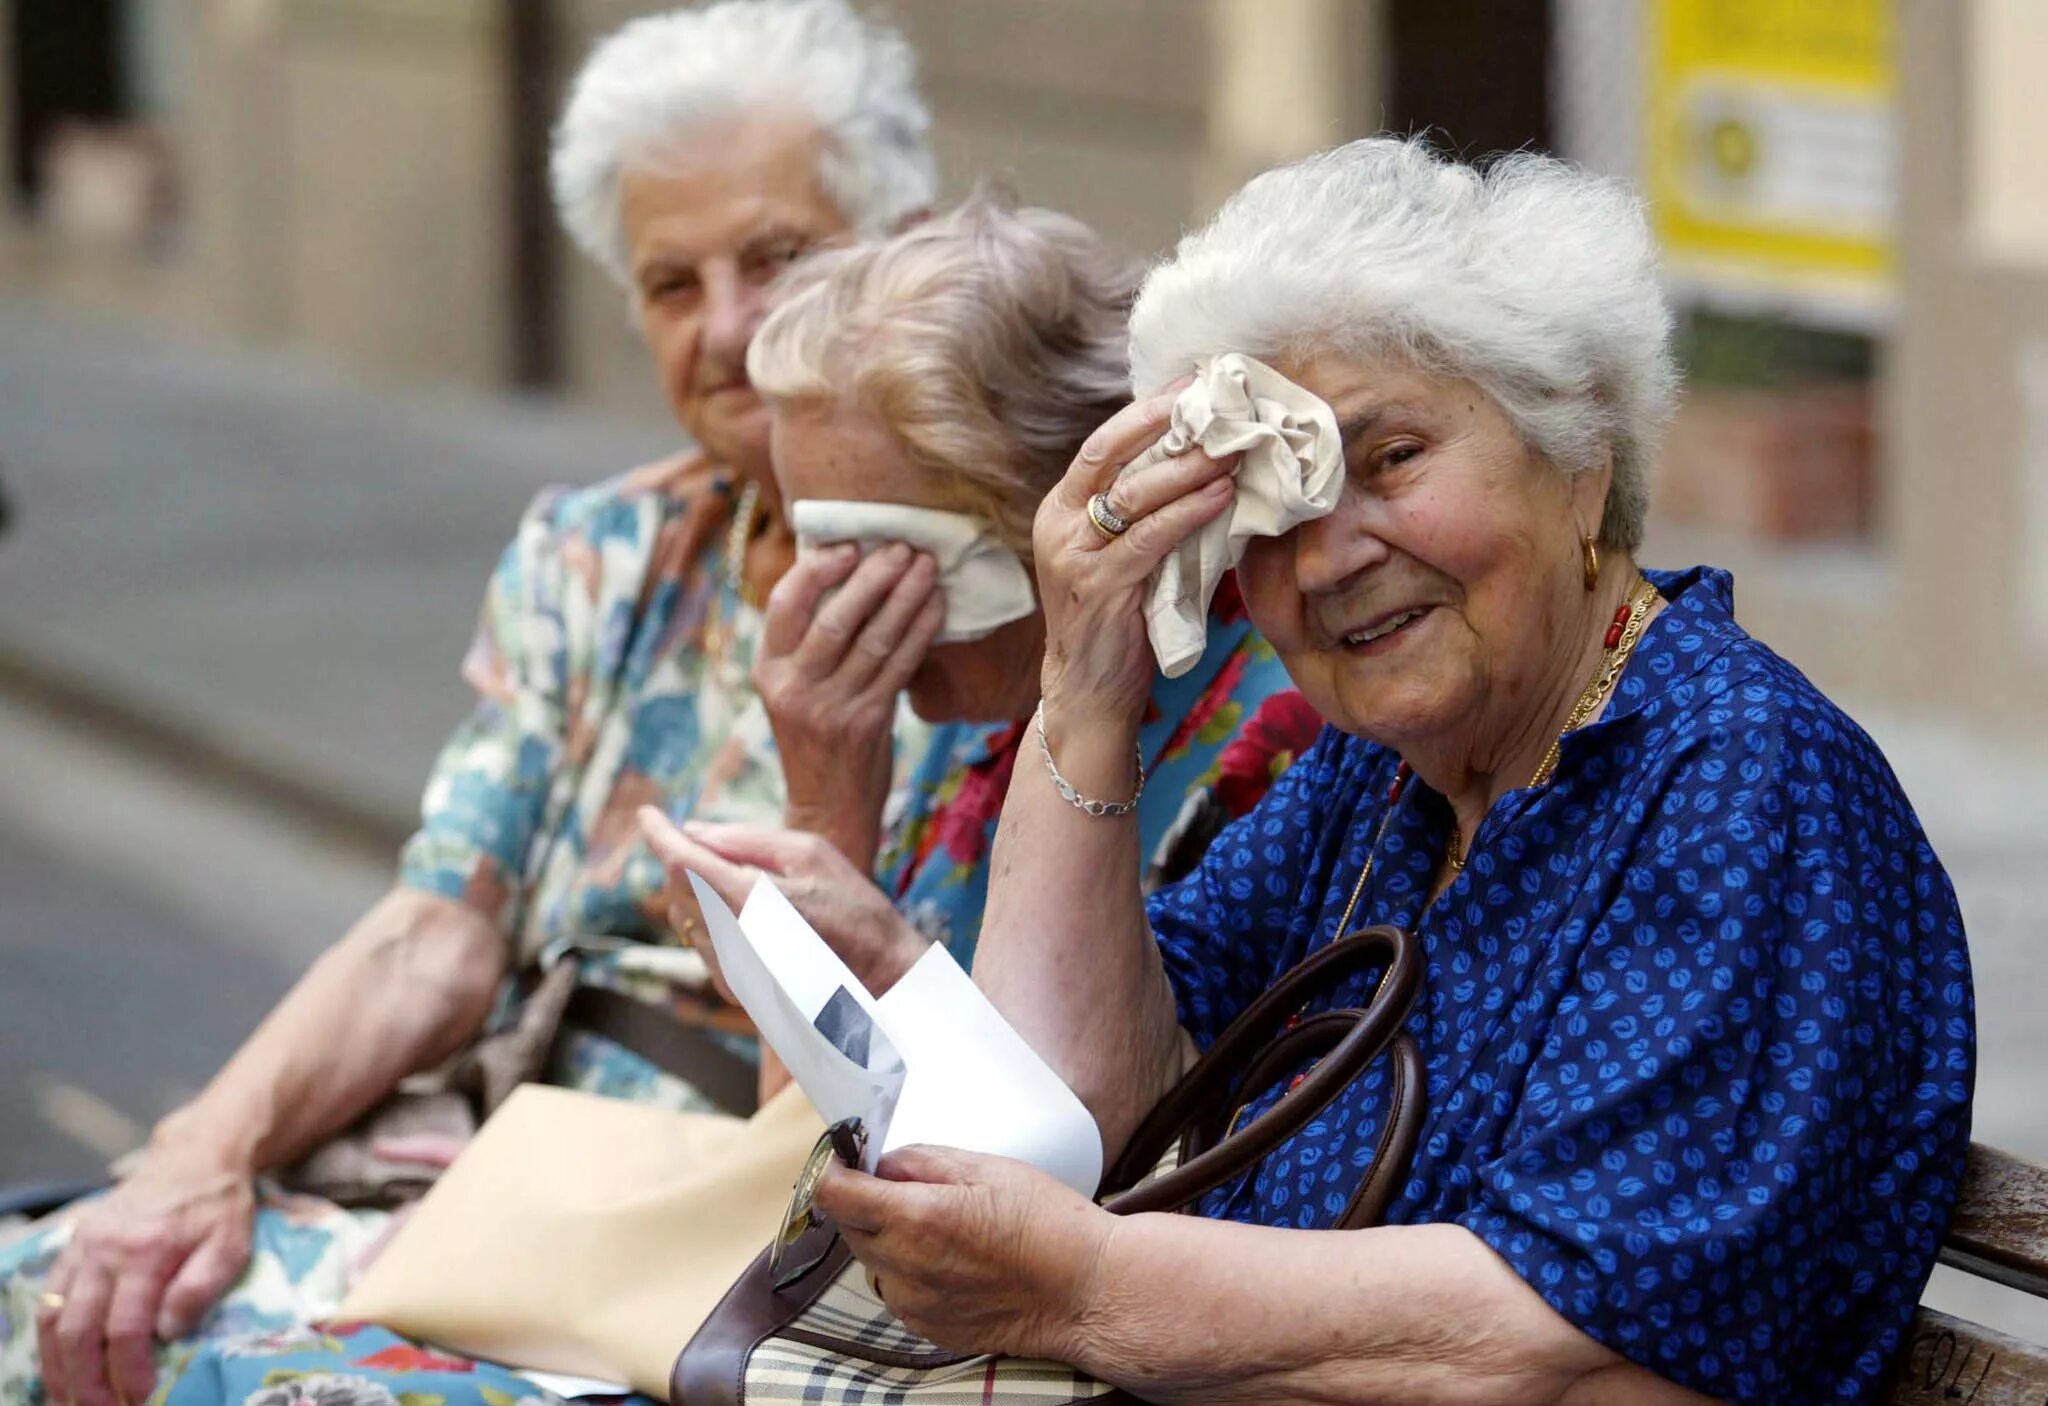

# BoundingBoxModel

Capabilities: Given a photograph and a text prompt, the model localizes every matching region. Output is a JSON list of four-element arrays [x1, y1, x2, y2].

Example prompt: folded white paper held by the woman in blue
[[690, 874, 1102, 1195]]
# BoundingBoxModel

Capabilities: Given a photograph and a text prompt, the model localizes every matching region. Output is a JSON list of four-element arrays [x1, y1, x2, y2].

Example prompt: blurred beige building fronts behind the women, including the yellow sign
[[12, 0, 2048, 729]]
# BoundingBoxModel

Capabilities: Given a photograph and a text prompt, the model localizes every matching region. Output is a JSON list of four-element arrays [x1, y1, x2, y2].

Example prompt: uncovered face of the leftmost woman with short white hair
[[621, 113, 846, 469]]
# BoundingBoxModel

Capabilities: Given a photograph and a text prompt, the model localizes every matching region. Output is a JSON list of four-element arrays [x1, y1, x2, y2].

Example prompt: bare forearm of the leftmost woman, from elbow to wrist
[[152, 890, 506, 1171]]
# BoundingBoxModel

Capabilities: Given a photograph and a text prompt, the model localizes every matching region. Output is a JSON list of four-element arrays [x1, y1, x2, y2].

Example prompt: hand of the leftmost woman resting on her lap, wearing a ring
[[35, 1148, 256, 1406]]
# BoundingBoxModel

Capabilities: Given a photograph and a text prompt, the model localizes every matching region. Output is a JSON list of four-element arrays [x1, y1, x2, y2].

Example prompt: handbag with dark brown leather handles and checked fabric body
[[670, 927, 1425, 1406]]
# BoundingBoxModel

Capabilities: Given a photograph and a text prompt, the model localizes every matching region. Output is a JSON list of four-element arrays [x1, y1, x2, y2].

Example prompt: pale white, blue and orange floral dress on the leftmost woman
[[0, 454, 784, 1406]]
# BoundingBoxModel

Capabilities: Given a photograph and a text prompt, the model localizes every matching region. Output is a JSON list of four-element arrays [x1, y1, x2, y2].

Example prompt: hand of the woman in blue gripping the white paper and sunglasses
[[817, 1146, 1116, 1363]]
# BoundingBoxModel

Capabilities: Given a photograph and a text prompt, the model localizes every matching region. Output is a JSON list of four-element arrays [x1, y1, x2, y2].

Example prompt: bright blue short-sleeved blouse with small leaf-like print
[[1151, 567, 1976, 1402]]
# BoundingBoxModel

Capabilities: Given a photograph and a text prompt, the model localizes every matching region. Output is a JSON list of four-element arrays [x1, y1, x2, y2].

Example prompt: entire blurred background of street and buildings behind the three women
[[0, 0, 2048, 1336]]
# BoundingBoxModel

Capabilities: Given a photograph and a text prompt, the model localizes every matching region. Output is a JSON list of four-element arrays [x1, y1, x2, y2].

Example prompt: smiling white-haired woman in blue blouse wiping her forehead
[[819, 141, 1974, 1402]]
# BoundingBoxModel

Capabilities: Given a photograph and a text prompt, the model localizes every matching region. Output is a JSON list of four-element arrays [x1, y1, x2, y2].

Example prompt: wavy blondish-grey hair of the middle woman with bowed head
[[748, 192, 1137, 561]]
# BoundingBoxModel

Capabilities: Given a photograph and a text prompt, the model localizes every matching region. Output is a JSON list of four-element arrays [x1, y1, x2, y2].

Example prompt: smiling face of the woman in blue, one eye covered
[[1239, 358, 1610, 765]]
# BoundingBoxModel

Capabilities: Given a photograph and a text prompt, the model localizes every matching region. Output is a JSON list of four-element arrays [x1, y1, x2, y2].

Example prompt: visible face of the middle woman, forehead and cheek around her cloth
[[770, 401, 1044, 722]]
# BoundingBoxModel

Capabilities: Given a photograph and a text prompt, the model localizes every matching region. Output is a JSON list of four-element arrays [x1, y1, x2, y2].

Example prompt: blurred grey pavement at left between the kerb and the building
[[0, 303, 676, 823]]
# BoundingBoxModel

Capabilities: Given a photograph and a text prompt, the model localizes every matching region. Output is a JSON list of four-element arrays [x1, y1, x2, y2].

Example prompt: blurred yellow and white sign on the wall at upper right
[[1649, 0, 1898, 325]]
